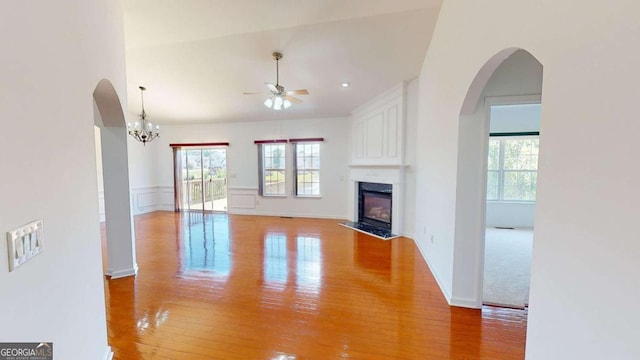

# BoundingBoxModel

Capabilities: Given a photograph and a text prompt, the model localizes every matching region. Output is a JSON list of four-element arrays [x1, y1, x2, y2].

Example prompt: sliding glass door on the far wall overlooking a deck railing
[[175, 148, 227, 211]]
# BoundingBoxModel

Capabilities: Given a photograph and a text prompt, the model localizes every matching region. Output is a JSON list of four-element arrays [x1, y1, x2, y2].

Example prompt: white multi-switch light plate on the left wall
[[7, 220, 42, 271]]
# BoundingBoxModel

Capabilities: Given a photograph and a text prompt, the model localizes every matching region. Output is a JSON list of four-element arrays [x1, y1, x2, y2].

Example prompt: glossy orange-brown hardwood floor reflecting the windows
[[103, 212, 527, 360]]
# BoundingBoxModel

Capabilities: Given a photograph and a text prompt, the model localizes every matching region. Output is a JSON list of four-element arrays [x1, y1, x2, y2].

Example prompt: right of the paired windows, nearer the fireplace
[[293, 142, 320, 196]]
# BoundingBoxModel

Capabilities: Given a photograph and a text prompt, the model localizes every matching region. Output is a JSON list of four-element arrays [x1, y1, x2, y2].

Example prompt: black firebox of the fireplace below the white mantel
[[357, 182, 393, 231]]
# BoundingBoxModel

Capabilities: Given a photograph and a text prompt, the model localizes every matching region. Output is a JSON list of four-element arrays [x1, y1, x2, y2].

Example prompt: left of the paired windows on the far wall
[[259, 143, 286, 196]]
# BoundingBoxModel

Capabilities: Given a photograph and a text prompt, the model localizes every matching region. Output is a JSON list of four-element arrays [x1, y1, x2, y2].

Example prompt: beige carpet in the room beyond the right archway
[[483, 228, 533, 308]]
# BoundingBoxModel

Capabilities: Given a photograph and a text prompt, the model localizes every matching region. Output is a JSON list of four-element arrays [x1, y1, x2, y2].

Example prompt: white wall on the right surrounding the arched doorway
[[416, 0, 640, 359]]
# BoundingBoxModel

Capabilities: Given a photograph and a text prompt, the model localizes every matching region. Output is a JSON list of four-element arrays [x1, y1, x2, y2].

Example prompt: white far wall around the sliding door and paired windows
[[141, 118, 349, 219]]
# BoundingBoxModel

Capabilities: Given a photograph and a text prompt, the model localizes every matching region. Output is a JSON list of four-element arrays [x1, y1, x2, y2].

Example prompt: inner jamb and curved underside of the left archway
[[93, 79, 138, 279]]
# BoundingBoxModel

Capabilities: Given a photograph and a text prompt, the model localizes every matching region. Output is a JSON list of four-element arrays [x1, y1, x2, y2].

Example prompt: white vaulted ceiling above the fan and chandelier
[[123, 0, 441, 124]]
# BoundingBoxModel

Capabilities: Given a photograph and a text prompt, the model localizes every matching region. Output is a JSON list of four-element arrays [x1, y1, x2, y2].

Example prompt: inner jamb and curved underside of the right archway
[[453, 48, 542, 308]]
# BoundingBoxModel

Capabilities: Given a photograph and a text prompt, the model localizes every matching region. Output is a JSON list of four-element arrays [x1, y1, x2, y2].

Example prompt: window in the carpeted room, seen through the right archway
[[487, 136, 539, 201]]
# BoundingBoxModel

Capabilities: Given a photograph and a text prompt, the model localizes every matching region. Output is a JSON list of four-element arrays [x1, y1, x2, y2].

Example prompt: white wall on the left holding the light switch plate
[[0, 0, 126, 360]]
